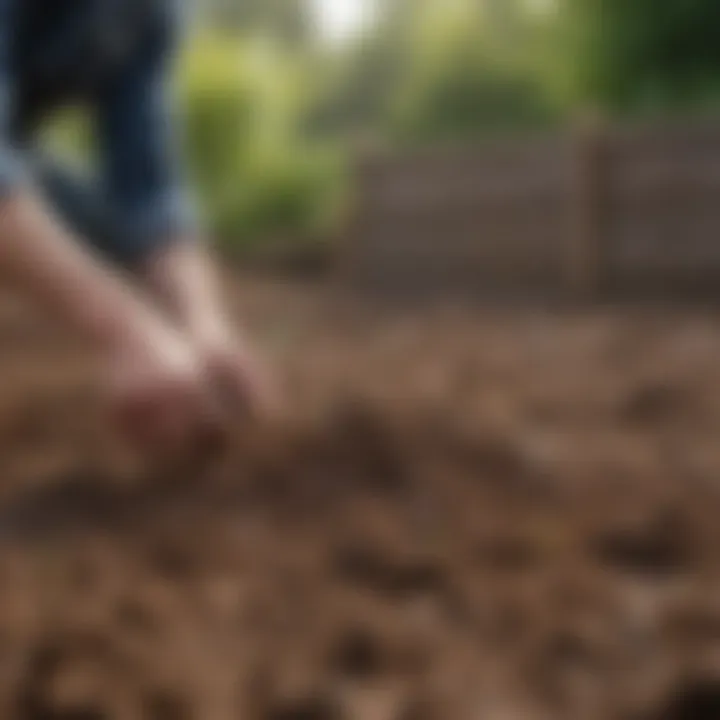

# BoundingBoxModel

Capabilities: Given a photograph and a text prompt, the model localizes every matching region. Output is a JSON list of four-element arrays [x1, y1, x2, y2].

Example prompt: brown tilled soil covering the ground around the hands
[[0, 281, 720, 720]]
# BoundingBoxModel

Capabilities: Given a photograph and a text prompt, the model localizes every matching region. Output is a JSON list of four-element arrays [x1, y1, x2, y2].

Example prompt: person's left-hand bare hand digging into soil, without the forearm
[[107, 325, 222, 458]]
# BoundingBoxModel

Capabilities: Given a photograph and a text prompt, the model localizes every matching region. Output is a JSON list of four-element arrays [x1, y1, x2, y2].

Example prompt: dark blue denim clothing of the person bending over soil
[[0, 0, 198, 266]]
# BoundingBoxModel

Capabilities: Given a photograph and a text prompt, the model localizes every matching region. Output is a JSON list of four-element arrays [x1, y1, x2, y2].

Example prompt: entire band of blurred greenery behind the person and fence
[[52, 0, 720, 249]]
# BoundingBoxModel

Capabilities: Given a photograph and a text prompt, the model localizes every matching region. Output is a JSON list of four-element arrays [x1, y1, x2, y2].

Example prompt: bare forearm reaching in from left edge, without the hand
[[0, 192, 169, 347]]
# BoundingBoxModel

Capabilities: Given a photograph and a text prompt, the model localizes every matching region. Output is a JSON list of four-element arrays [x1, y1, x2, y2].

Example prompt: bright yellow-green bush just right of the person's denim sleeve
[[180, 35, 342, 243]]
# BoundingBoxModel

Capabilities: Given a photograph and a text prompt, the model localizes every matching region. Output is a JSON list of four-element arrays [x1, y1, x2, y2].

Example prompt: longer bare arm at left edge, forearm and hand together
[[0, 191, 226, 456]]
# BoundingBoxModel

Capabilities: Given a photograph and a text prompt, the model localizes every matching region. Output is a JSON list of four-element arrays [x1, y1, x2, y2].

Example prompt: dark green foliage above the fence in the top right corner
[[561, 0, 720, 110]]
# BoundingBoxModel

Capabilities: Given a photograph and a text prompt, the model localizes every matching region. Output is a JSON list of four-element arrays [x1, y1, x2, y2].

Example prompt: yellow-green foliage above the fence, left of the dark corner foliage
[[306, 0, 558, 144]]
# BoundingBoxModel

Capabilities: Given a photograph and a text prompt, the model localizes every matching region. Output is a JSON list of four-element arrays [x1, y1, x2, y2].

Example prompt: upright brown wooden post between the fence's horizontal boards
[[565, 118, 608, 300]]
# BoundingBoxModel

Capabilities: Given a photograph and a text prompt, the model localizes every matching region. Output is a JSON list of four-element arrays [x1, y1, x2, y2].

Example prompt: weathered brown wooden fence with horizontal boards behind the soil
[[344, 122, 720, 298]]
